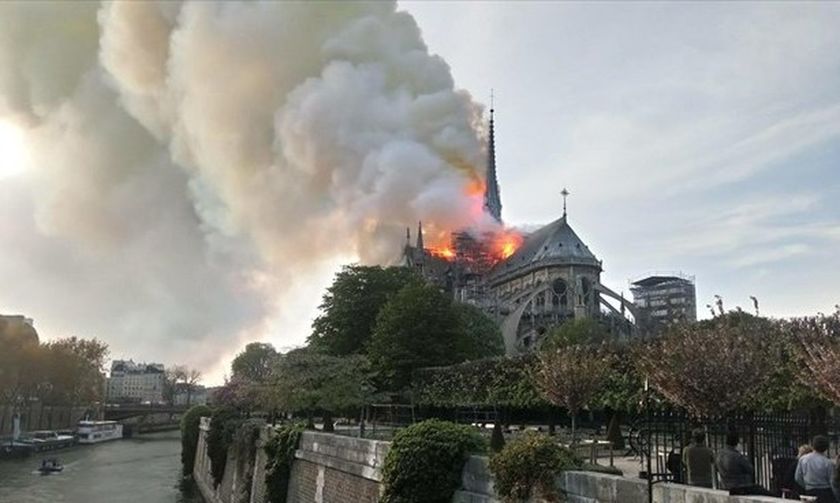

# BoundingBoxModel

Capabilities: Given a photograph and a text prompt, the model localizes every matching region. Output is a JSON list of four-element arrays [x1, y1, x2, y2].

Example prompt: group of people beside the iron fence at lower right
[[682, 431, 840, 503]]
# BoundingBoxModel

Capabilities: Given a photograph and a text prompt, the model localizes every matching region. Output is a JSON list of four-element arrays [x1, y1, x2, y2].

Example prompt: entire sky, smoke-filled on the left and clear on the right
[[0, 1, 840, 383]]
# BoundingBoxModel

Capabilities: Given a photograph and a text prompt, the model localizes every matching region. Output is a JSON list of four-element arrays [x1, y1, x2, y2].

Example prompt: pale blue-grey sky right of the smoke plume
[[400, 2, 840, 316]]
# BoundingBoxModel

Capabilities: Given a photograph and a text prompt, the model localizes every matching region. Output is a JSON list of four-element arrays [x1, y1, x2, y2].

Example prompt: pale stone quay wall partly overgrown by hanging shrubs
[[193, 426, 783, 503]]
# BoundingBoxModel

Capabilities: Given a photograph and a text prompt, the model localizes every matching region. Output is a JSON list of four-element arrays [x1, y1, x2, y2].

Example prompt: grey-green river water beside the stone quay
[[0, 432, 201, 503]]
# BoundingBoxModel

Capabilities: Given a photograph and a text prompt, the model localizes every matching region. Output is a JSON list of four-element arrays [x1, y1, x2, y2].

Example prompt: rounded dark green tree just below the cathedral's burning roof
[[368, 283, 468, 390]]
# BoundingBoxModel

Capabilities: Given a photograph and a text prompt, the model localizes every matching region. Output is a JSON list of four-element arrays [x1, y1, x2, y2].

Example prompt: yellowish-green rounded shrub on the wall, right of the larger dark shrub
[[490, 433, 582, 501]]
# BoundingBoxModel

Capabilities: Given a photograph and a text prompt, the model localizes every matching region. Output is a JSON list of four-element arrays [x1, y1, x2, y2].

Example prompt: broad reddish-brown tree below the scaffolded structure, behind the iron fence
[[636, 312, 780, 416]]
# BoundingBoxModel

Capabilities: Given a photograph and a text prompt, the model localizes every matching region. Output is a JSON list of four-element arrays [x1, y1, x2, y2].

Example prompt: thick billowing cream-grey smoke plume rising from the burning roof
[[0, 1, 496, 378]]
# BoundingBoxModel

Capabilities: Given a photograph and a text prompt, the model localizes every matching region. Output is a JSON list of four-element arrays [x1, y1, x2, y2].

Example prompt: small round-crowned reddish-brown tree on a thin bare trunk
[[534, 344, 610, 442]]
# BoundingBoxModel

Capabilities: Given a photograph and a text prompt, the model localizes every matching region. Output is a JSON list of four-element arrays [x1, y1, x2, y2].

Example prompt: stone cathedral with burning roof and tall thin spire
[[402, 108, 636, 355]]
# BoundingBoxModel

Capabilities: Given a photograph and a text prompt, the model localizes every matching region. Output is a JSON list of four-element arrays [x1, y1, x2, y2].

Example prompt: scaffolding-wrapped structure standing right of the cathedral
[[630, 274, 697, 333]]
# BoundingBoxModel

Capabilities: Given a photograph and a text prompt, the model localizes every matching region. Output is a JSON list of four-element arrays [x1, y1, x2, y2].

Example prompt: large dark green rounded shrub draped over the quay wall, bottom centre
[[380, 419, 485, 503]]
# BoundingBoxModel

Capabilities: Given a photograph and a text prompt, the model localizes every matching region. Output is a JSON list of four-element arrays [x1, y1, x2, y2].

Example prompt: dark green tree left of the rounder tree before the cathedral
[[308, 265, 419, 355]]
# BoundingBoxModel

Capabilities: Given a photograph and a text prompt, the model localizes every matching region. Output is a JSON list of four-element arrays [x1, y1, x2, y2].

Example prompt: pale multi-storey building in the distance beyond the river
[[105, 360, 166, 403]]
